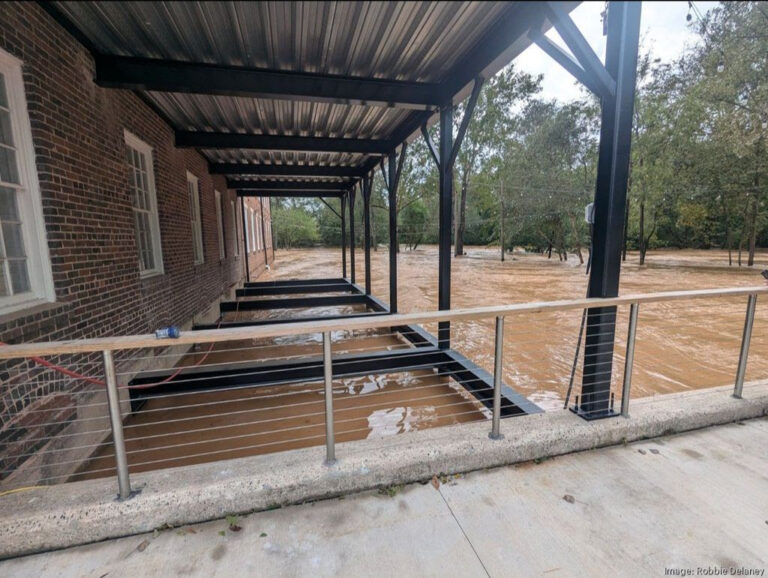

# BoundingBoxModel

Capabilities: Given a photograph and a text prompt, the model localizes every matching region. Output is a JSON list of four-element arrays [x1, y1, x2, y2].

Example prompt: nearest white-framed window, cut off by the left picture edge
[[0, 50, 55, 314]]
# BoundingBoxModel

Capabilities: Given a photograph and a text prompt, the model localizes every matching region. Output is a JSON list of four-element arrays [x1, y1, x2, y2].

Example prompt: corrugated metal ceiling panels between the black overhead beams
[[48, 2, 560, 181]]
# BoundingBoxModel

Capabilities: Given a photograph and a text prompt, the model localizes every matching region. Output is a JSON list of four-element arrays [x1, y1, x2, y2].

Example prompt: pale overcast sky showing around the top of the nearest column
[[515, 1, 717, 101]]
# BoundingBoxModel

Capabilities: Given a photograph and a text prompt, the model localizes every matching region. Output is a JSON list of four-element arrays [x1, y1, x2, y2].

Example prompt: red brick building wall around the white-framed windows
[[0, 2, 270, 470]]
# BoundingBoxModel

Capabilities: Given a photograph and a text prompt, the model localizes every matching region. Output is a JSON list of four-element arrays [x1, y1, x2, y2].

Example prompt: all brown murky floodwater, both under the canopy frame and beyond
[[78, 246, 768, 479]]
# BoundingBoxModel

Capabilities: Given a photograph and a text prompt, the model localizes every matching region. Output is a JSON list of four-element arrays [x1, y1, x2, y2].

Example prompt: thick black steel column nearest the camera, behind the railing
[[574, 2, 640, 419]]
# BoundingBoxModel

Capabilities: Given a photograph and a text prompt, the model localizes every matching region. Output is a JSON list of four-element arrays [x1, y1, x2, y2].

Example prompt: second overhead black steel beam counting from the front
[[176, 131, 392, 155]]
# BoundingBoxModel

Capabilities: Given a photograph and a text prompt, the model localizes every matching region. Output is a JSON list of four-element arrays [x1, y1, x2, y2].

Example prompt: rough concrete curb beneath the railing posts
[[0, 383, 768, 558]]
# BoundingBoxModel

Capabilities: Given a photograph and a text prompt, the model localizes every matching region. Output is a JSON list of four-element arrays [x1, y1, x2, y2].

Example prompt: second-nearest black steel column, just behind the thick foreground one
[[437, 104, 453, 349]]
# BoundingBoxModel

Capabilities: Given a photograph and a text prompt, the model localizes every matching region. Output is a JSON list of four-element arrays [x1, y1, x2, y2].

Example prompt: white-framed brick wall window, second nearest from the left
[[125, 131, 163, 277]]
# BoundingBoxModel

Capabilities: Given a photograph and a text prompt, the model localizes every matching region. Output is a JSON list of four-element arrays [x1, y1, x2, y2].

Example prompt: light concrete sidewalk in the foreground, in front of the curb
[[0, 418, 768, 578]]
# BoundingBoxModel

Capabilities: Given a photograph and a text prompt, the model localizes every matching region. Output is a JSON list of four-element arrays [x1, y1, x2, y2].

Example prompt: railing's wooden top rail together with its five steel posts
[[0, 286, 768, 499]]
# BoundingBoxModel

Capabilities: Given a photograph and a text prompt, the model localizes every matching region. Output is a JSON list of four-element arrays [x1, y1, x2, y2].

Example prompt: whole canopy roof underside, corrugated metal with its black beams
[[42, 2, 578, 195]]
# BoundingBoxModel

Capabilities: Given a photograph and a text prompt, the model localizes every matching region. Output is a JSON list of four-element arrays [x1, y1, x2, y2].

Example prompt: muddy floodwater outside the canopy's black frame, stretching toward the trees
[[259, 246, 768, 409]]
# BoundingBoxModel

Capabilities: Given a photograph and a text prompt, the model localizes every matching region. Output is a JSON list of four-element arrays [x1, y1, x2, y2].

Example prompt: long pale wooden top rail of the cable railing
[[0, 285, 768, 359]]
